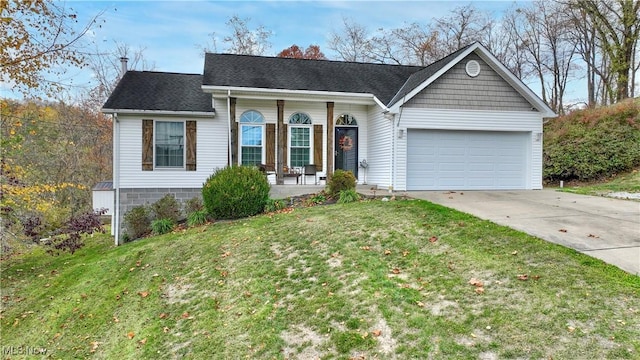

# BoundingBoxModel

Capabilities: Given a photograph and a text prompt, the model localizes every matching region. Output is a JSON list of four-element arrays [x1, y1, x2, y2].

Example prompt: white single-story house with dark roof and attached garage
[[102, 43, 555, 245]]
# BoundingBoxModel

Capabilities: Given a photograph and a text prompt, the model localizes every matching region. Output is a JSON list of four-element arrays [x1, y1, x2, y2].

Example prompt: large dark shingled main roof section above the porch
[[203, 53, 424, 104]]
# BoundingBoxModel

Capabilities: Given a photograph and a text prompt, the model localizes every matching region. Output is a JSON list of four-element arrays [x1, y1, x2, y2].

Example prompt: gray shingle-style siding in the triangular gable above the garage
[[405, 53, 532, 111]]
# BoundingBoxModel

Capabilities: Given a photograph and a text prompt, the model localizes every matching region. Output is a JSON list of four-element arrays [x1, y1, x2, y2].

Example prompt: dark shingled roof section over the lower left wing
[[103, 71, 214, 113]]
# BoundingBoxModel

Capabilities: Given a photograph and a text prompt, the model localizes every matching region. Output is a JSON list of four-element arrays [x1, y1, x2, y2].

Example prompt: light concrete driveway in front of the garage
[[408, 190, 640, 275]]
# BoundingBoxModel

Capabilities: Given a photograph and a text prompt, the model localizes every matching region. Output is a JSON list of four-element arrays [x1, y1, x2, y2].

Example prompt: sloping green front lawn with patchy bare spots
[[0, 200, 640, 359]]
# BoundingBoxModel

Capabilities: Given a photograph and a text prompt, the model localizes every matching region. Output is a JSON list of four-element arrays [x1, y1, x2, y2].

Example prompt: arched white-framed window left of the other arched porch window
[[240, 110, 265, 165]]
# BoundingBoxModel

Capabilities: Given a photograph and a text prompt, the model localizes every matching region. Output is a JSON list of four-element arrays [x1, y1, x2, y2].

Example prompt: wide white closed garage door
[[407, 129, 530, 190]]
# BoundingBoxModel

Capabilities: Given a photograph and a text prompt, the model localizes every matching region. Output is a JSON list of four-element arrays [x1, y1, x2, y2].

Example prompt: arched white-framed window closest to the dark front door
[[289, 112, 313, 167]]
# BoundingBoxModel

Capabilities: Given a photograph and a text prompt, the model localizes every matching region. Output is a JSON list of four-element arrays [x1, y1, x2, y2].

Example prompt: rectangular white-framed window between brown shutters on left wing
[[153, 121, 185, 169]]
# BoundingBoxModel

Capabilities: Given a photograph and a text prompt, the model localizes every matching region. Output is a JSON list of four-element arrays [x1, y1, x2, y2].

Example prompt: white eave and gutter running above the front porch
[[202, 85, 381, 105]]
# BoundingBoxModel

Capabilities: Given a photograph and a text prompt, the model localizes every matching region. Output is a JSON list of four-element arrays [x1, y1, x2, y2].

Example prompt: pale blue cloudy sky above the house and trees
[[0, 0, 576, 102]]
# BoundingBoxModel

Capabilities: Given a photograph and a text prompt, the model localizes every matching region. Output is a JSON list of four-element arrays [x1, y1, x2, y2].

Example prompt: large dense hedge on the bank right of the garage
[[544, 100, 640, 181]]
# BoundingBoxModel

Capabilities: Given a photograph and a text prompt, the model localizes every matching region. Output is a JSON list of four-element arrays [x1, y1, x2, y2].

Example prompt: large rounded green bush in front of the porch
[[202, 166, 269, 219]]
